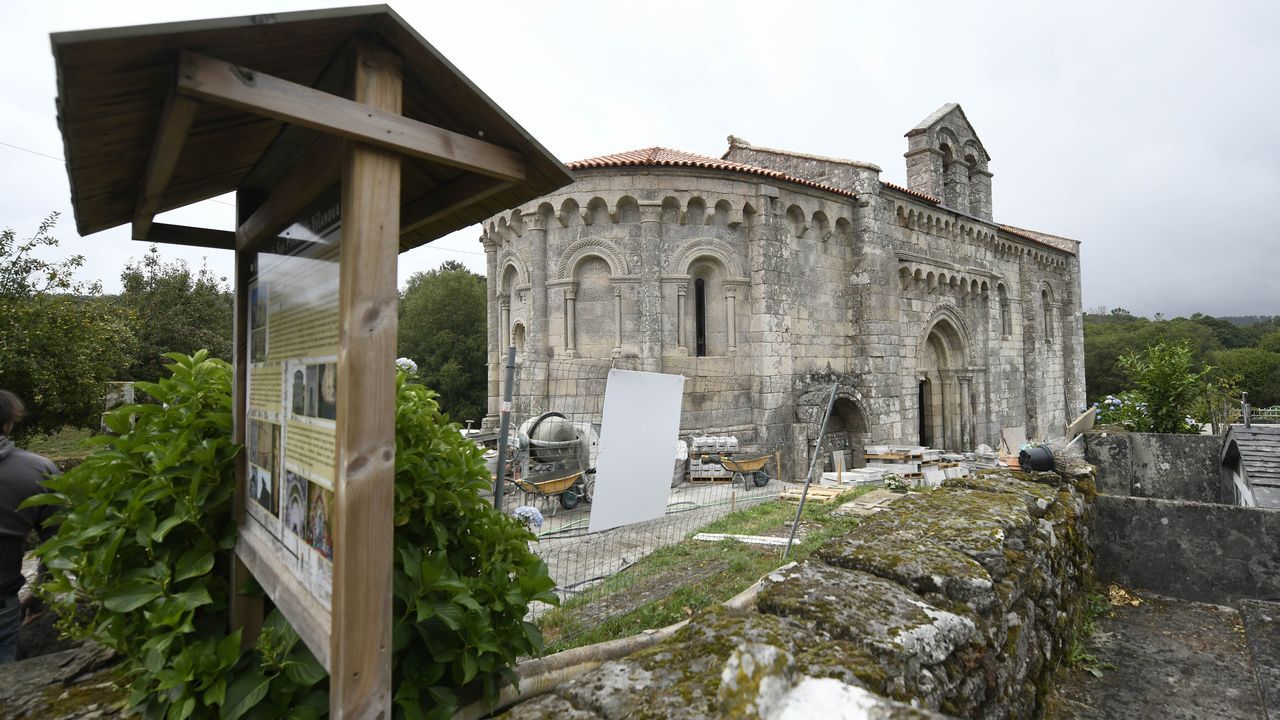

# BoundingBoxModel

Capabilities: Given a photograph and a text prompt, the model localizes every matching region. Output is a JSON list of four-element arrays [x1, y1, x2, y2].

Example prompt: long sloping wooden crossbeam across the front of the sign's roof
[[178, 53, 525, 182]]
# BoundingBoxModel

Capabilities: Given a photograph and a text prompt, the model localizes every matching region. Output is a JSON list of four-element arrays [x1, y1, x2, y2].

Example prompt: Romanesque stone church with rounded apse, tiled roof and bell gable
[[481, 104, 1084, 475]]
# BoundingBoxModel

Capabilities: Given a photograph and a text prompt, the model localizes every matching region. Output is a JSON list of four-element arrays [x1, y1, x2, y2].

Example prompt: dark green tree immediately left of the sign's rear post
[[119, 245, 234, 382]]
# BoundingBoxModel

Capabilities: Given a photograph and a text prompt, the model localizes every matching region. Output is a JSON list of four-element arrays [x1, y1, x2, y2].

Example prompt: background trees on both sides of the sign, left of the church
[[0, 213, 488, 434]]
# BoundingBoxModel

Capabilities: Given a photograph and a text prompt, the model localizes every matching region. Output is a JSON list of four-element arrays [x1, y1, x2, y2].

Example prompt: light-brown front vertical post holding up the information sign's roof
[[329, 44, 403, 720]]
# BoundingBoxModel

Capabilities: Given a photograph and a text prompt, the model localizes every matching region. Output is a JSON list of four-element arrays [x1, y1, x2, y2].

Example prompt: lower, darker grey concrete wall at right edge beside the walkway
[[1094, 495, 1280, 605]]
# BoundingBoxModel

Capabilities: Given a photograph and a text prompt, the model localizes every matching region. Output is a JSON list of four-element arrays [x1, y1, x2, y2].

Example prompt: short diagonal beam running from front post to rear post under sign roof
[[236, 136, 342, 251]]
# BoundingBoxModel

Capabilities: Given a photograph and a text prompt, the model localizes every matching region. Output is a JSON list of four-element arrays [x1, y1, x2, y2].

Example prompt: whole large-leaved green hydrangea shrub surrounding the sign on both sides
[[32, 351, 556, 720]]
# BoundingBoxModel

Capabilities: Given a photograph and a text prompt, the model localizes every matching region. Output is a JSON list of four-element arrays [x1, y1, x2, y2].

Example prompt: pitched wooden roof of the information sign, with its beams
[[51, 5, 572, 250]]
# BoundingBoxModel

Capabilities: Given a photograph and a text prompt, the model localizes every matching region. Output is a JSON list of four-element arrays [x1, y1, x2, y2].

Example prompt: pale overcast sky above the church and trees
[[0, 0, 1280, 316]]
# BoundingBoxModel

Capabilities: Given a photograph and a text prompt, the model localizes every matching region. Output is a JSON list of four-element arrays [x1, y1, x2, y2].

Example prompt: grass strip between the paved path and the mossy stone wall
[[538, 488, 870, 653]]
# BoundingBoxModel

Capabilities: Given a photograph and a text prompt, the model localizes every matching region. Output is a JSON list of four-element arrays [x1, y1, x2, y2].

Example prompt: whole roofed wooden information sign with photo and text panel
[[51, 5, 572, 719]]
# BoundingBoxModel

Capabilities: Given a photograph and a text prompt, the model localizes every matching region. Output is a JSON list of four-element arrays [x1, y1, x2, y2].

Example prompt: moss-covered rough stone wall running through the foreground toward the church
[[507, 461, 1094, 720]]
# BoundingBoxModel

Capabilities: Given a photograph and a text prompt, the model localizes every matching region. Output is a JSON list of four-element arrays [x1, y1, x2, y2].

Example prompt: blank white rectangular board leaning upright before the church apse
[[589, 370, 685, 533]]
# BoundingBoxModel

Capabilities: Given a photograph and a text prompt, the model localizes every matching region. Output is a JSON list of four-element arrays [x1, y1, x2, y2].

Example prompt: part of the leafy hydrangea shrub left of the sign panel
[[32, 352, 241, 719]]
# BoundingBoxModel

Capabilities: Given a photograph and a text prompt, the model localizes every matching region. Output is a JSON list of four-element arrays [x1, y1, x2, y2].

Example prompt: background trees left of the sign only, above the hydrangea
[[0, 213, 232, 434]]
